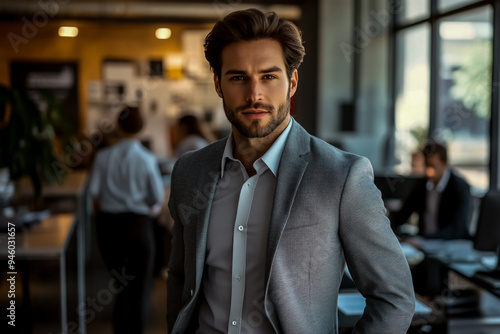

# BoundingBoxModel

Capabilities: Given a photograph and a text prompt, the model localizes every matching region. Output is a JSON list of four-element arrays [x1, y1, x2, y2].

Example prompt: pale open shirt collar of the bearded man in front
[[220, 117, 293, 178]]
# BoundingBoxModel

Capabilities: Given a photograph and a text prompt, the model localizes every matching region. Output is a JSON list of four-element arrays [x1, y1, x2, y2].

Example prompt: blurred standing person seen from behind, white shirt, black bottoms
[[89, 107, 165, 334]]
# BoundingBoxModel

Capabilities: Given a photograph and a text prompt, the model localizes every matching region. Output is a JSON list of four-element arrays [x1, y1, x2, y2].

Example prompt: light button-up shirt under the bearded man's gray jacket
[[197, 122, 292, 334]]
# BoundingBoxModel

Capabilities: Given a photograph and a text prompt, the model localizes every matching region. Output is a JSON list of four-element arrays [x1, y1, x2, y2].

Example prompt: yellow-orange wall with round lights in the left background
[[0, 18, 210, 128]]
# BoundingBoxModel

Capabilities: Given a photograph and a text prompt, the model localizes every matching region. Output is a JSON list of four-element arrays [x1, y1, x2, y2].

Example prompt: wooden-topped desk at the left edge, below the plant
[[0, 214, 77, 333]]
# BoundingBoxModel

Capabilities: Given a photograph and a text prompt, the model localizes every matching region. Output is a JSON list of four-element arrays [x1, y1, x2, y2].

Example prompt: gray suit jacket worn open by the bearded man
[[167, 120, 415, 334]]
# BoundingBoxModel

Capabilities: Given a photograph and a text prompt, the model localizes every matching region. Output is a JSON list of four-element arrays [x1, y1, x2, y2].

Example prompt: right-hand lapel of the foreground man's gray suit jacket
[[265, 119, 310, 282]]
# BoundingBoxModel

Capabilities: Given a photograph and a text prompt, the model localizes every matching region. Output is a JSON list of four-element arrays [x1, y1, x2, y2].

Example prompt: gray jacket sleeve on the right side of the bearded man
[[339, 158, 415, 334]]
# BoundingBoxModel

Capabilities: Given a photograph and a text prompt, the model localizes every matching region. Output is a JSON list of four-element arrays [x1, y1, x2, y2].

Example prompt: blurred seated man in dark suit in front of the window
[[391, 141, 470, 239]]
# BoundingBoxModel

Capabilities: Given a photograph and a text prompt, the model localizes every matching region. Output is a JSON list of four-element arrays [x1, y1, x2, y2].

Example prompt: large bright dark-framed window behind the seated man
[[394, 0, 498, 192]]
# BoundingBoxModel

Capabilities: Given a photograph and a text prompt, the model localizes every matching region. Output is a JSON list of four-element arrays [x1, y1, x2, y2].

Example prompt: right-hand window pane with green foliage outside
[[438, 6, 493, 189]]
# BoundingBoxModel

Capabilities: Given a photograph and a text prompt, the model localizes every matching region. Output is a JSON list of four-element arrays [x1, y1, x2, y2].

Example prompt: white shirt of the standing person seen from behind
[[89, 139, 165, 215]]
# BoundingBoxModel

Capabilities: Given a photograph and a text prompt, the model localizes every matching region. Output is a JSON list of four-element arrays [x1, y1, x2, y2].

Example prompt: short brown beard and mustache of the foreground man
[[222, 95, 290, 138]]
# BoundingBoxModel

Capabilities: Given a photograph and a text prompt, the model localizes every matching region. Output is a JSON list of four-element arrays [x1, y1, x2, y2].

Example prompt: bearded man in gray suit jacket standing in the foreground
[[167, 9, 415, 334]]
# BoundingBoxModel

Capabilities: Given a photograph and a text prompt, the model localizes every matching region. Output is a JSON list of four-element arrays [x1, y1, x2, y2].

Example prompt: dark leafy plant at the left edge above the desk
[[0, 85, 61, 197]]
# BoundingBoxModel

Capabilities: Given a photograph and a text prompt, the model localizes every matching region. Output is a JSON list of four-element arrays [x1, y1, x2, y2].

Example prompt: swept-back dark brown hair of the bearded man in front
[[204, 8, 305, 78]]
